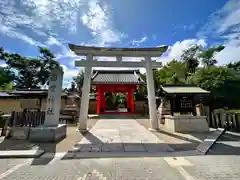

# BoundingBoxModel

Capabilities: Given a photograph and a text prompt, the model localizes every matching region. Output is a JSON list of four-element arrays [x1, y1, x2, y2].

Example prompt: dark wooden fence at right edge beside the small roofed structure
[[202, 107, 240, 132]]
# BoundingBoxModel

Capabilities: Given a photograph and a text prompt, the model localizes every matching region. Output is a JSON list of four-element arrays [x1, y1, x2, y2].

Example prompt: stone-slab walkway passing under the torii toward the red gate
[[75, 119, 173, 152]]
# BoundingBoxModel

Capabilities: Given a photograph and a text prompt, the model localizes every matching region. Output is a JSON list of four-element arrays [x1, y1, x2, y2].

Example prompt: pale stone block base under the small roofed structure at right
[[164, 115, 209, 133]]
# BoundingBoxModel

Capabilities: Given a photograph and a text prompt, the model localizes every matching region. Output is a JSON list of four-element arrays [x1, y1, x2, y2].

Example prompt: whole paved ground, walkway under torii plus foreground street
[[0, 119, 240, 180]]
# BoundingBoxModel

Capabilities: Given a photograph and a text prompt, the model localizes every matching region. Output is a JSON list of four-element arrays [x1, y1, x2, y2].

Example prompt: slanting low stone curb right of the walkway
[[196, 128, 226, 155]]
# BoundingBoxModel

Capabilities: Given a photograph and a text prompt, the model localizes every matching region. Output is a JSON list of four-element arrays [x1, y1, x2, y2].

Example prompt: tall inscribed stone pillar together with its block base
[[29, 69, 67, 142]]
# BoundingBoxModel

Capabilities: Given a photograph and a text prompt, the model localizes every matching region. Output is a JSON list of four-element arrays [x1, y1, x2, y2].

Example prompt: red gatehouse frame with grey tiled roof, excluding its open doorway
[[92, 70, 144, 114]]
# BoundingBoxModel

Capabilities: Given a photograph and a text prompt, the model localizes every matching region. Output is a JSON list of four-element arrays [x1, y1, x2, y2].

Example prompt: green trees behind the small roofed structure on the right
[[136, 45, 240, 108]]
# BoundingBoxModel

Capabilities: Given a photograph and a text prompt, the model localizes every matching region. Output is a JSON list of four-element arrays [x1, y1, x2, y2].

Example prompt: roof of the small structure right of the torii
[[161, 84, 210, 94]]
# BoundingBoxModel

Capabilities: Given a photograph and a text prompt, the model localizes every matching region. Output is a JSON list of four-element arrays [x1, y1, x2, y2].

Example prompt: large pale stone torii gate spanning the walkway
[[69, 44, 168, 131]]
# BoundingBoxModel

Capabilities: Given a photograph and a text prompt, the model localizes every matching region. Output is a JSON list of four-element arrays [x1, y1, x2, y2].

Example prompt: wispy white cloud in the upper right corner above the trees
[[197, 0, 240, 64]]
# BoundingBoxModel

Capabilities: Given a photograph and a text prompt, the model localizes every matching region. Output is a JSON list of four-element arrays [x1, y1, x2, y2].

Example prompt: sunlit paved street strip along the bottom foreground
[[0, 156, 240, 180]]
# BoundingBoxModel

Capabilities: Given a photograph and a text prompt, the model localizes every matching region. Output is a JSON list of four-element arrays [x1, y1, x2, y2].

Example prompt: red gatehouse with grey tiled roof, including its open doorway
[[92, 70, 144, 114]]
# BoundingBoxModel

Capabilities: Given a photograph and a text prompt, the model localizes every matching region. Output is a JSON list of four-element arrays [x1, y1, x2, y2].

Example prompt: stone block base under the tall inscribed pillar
[[29, 124, 67, 142]]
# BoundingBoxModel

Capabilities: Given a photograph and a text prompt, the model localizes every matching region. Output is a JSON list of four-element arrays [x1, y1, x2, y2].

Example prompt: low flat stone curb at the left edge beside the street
[[0, 150, 44, 159]]
